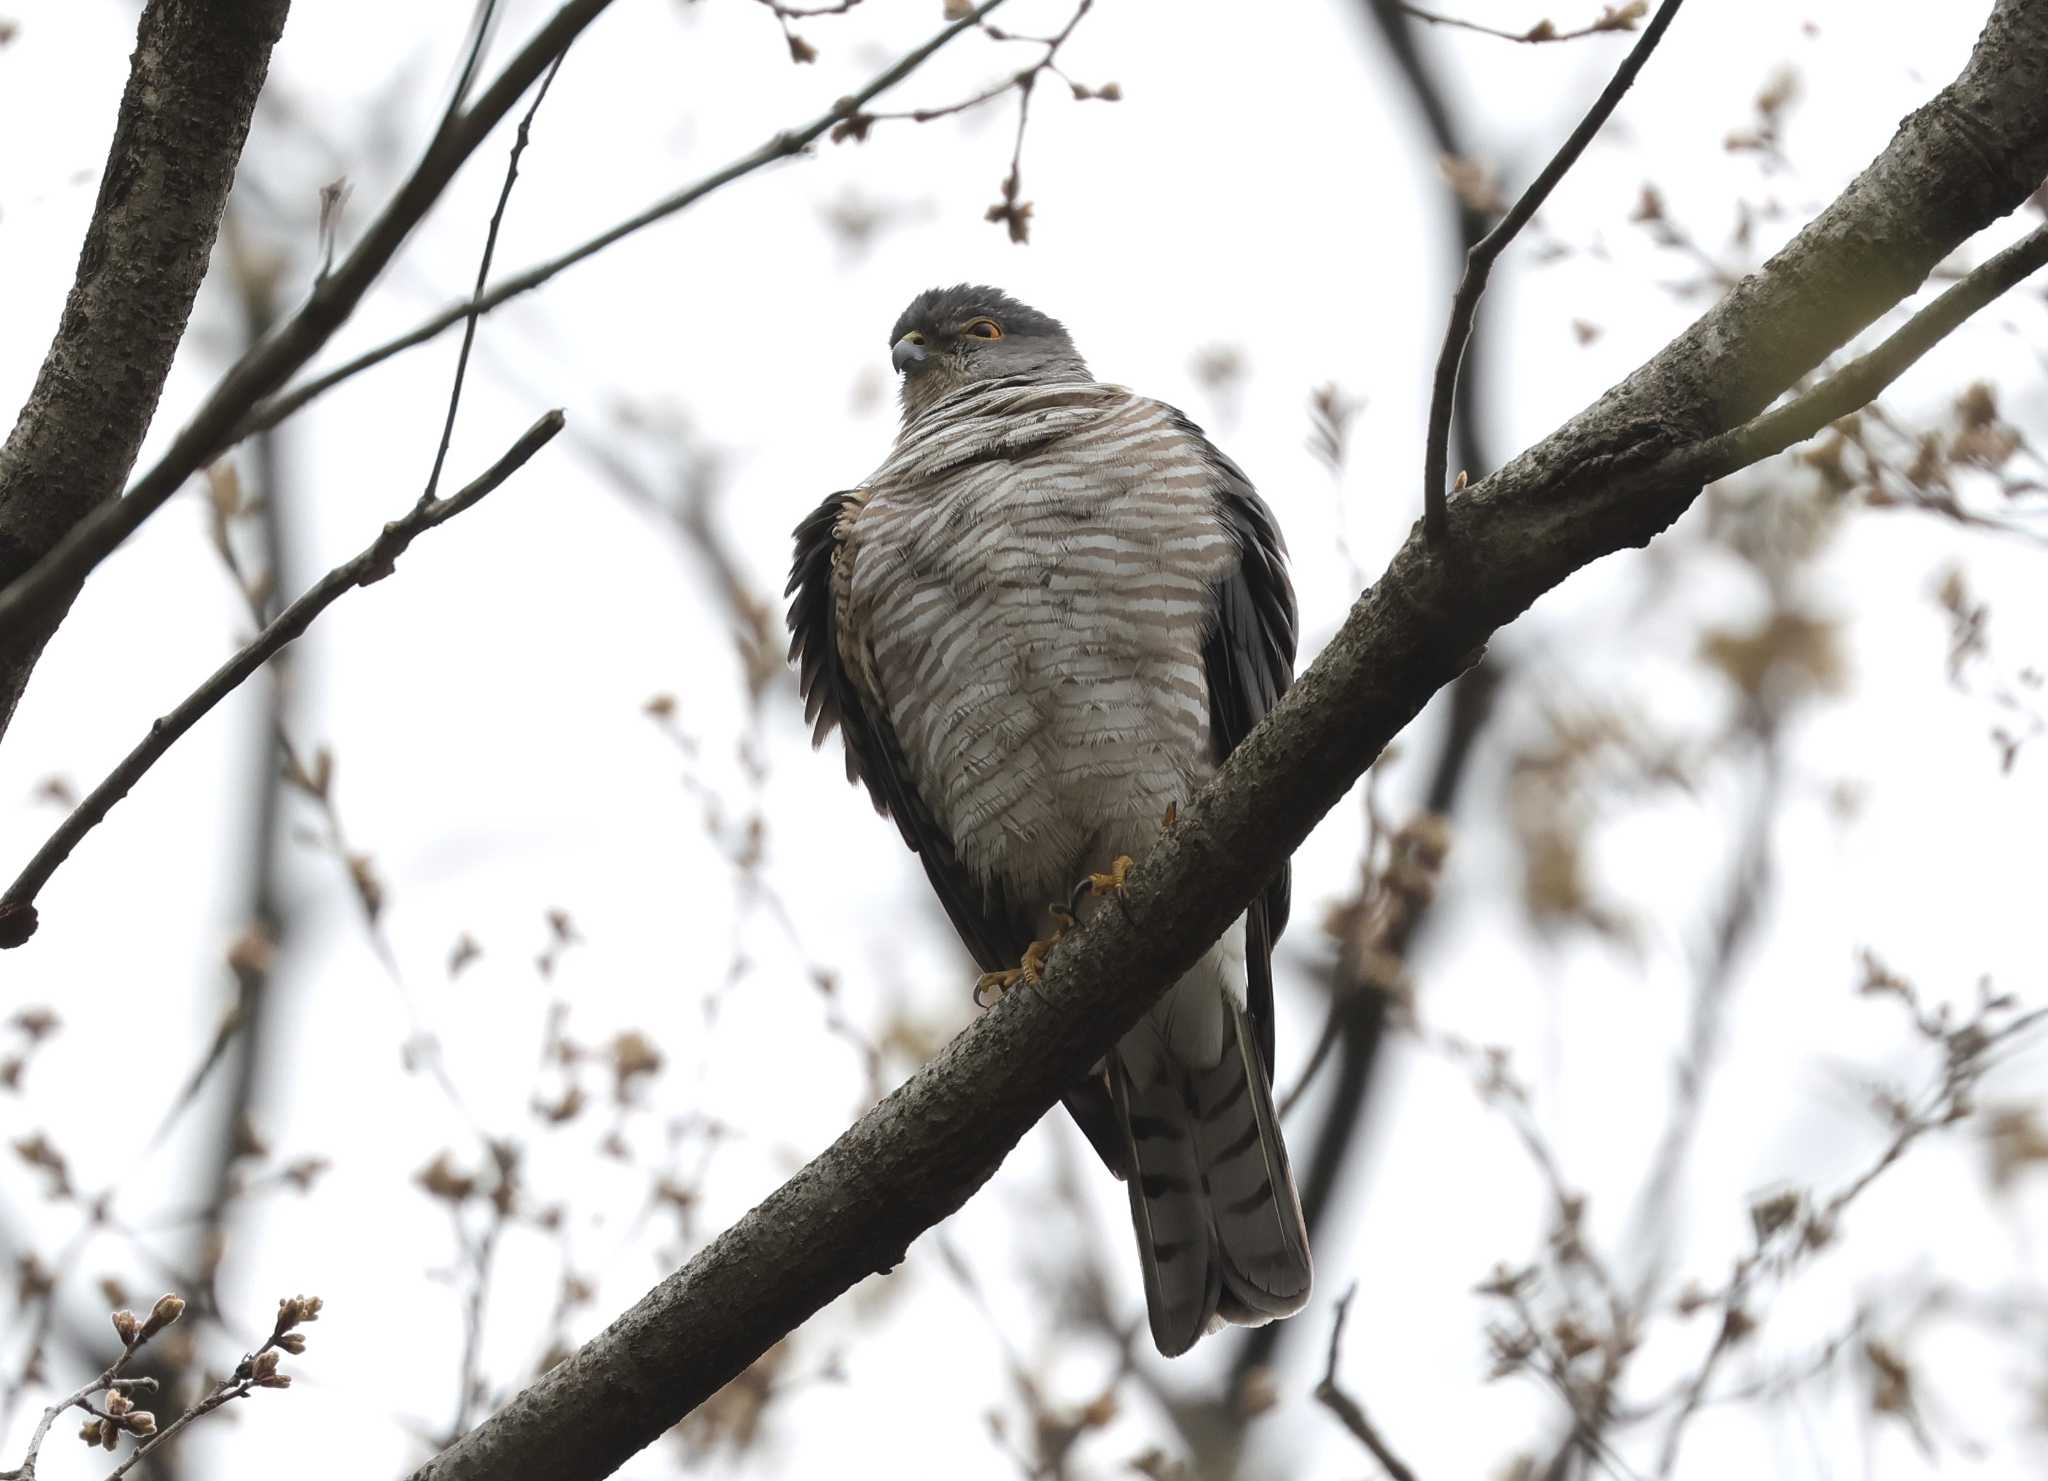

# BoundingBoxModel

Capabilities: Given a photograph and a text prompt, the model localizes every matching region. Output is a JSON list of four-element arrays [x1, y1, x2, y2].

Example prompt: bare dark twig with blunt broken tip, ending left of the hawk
[[0, 412, 565, 948]]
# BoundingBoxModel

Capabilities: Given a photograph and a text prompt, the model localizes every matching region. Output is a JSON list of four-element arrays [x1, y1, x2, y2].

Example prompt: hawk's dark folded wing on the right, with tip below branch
[[1180, 418, 1296, 1077]]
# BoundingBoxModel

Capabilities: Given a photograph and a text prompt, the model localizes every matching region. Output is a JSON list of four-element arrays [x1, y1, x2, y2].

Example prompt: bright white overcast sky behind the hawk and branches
[[0, 0, 2048, 1479]]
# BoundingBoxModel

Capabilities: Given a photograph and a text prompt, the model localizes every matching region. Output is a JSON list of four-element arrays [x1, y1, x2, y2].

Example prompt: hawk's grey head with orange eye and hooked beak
[[889, 283, 1090, 422]]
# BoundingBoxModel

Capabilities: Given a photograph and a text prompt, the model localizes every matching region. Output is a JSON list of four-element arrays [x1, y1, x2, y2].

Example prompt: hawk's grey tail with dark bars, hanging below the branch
[[1110, 1000, 1313, 1358]]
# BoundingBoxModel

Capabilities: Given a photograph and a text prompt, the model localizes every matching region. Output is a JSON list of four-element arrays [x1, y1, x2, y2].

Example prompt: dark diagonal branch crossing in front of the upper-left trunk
[[0, 0, 610, 647]]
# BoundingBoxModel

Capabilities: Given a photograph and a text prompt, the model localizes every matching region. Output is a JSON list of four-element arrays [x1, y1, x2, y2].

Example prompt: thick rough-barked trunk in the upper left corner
[[0, 0, 291, 733]]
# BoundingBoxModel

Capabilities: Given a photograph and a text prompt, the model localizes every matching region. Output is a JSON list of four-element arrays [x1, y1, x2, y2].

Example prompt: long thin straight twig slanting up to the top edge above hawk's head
[[228, 0, 1004, 453]]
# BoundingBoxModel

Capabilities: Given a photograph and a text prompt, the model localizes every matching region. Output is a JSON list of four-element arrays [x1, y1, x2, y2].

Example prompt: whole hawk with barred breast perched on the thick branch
[[788, 285, 1311, 1356]]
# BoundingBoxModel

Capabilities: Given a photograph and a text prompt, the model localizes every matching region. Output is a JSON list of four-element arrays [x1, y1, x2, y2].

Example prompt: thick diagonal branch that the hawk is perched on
[[399, 0, 2048, 1481]]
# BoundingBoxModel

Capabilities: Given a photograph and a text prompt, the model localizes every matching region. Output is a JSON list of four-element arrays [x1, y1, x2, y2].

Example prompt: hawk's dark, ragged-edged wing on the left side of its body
[[784, 494, 1032, 971]]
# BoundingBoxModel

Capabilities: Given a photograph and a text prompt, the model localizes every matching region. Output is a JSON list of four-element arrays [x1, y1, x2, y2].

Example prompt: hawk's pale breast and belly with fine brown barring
[[848, 383, 1237, 899]]
